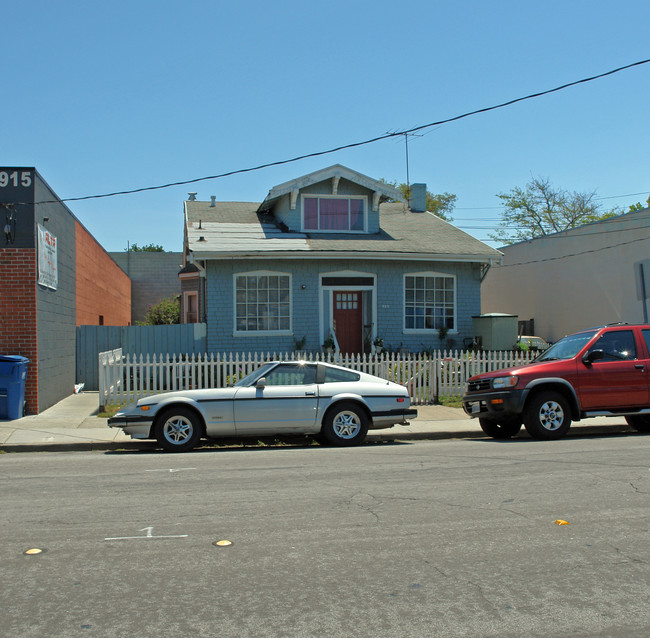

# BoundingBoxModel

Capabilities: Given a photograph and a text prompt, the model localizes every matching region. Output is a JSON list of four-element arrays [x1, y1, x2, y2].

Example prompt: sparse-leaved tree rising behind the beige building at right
[[490, 177, 622, 244]]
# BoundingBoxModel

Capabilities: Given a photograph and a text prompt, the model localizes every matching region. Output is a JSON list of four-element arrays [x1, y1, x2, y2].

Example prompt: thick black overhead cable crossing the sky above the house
[[22, 59, 650, 204]]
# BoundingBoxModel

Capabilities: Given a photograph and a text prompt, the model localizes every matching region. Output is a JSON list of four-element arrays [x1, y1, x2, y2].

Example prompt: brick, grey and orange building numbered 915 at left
[[0, 167, 131, 413]]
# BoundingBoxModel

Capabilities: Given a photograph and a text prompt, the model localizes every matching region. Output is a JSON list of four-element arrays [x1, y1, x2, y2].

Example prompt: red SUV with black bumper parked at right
[[463, 324, 650, 439]]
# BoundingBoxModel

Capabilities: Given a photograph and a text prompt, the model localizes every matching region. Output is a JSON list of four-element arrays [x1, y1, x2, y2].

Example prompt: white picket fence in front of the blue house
[[99, 349, 533, 409]]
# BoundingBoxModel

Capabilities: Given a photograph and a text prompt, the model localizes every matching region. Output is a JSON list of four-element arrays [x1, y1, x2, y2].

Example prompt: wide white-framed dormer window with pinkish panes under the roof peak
[[303, 196, 366, 232]]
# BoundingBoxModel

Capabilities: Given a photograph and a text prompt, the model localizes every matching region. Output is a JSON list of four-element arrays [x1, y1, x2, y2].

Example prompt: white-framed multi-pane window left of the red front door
[[235, 273, 291, 333]]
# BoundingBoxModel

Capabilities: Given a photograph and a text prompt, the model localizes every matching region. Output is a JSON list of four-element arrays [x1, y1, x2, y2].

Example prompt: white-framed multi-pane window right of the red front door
[[404, 273, 456, 330]]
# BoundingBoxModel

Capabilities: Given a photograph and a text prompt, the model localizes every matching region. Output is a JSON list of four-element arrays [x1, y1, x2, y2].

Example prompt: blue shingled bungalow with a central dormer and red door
[[179, 164, 501, 353]]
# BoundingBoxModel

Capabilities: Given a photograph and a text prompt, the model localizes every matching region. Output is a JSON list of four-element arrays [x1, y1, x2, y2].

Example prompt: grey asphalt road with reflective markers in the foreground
[[0, 434, 650, 638]]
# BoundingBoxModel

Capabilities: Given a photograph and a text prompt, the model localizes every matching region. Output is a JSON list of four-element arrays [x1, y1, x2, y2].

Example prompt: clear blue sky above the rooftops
[[5, 0, 650, 251]]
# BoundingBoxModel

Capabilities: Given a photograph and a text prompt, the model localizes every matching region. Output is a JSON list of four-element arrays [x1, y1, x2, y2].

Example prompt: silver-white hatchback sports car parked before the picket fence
[[108, 361, 417, 452]]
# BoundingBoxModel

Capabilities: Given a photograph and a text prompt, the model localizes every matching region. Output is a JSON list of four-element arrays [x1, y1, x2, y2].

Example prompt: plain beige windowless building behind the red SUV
[[482, 208, 650, 341]]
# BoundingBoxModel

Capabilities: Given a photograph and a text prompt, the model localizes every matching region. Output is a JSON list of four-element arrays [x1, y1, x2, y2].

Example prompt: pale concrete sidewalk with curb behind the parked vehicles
[[0, 392, 633, 452]]
